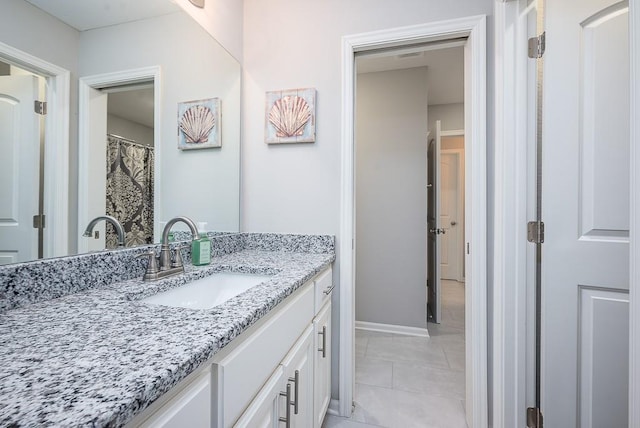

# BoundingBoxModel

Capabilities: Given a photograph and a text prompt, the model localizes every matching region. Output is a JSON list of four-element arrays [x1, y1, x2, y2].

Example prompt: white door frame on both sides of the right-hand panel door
[[492, 0, 640, 427]]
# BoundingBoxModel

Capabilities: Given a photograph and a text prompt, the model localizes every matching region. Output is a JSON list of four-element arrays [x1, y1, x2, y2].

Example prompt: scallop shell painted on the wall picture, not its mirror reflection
[[269, 95, 311, 138]]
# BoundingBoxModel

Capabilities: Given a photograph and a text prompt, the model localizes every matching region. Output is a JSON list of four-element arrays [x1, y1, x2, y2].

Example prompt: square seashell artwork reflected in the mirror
[[178, 98, 222, 150]]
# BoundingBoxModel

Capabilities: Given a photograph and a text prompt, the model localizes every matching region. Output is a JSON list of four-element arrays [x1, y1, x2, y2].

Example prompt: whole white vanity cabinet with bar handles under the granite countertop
[[127, 268, 333, 428]]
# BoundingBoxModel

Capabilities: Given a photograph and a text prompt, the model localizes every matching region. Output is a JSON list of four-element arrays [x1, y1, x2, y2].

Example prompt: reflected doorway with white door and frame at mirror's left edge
[[0, 42, 70, 264]]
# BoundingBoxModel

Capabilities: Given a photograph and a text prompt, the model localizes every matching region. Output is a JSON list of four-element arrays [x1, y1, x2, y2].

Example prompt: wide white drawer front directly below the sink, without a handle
[[212, 282, 314, 427]]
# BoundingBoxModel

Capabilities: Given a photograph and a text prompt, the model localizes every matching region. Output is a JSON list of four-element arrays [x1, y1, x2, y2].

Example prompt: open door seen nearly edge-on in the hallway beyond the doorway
[[427, 120, 443, 323]]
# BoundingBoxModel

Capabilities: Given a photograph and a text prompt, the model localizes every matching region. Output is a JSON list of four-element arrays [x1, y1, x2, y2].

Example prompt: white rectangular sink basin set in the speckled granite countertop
[[142, 272, 271, 309]]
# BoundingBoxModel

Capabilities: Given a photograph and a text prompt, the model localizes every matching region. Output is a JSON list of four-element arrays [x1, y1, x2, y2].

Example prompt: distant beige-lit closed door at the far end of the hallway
[[440, 151, 461, 281]]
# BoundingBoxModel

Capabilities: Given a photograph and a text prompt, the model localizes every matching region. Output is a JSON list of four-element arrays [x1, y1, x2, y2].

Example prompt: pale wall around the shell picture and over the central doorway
[[241, 0, 494, 398]]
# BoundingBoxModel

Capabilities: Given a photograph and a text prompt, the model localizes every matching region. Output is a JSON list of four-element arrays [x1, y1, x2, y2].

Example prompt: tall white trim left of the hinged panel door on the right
[[492, 1, 535, 427]]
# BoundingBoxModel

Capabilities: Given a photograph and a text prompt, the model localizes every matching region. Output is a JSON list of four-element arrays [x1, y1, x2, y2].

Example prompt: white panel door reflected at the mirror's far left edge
[[0, 76, 40, 265]]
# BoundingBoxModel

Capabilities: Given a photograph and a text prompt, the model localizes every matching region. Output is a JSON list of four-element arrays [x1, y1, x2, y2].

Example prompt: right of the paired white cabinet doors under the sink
[[282, 324, 314, 428]]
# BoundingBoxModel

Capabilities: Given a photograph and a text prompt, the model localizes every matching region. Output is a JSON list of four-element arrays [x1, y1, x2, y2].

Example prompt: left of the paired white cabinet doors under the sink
[[234, 366, 286, 428]]
